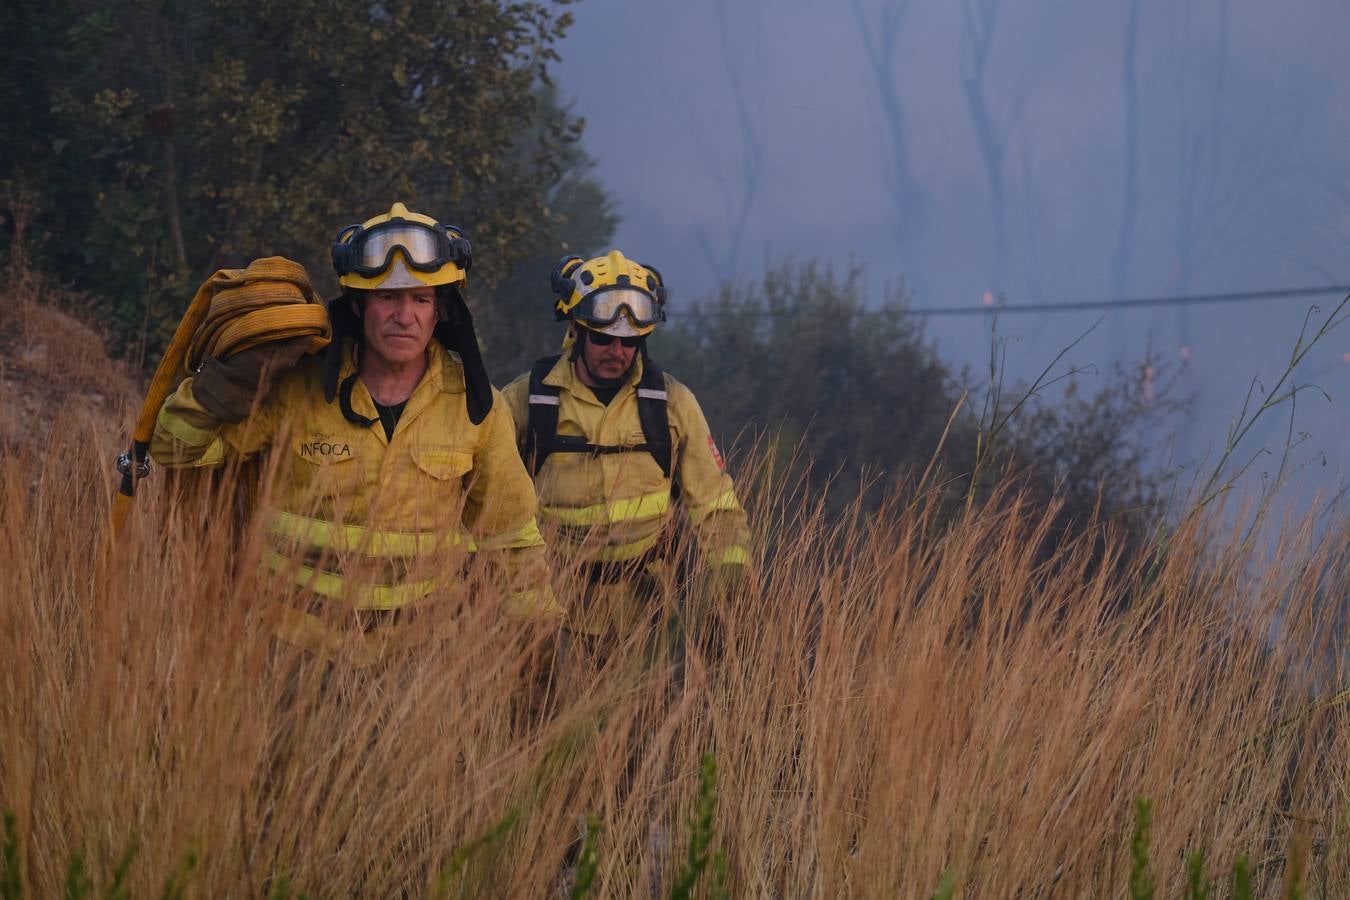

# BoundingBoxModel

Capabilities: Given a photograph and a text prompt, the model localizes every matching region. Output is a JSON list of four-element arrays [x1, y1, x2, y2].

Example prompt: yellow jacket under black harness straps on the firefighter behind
[[502, 354, 749, 574]]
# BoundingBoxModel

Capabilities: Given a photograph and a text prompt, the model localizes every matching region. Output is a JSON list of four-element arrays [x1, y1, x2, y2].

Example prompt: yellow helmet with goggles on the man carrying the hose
[[333, 204, 473, 290]]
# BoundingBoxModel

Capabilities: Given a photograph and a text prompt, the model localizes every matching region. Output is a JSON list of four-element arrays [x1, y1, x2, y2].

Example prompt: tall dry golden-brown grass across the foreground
[[0, 404, 1350, 897]]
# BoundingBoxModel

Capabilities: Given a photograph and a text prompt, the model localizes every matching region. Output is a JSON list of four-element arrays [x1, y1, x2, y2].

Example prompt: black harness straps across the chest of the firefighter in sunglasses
[[521, 356, 671, 479]]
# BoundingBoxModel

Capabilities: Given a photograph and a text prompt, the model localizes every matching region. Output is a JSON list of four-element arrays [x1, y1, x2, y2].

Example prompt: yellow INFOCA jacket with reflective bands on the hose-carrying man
[[150, 341, 562, 661]]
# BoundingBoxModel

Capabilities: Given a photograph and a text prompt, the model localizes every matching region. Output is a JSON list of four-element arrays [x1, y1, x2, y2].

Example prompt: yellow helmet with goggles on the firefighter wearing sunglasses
[[549, 250, 667, 337]]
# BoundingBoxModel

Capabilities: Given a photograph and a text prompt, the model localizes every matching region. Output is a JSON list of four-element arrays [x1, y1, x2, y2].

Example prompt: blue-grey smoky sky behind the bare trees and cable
[[556, 0, 1350, 488]]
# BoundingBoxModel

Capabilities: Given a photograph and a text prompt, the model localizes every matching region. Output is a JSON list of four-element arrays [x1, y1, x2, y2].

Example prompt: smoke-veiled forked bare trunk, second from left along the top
[[851, 0, 925, 266]]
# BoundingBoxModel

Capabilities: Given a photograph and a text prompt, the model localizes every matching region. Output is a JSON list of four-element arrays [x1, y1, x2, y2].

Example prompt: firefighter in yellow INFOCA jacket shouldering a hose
[[151, 204, 563, 664]]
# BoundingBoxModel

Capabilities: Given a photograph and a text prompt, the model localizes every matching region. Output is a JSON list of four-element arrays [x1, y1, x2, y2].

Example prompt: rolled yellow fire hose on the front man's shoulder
[[112, 256, 332, 537]]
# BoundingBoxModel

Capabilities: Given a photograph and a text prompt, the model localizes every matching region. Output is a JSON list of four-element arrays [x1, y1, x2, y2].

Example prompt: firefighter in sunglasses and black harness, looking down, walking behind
[[502, 250, 748, 636]]
